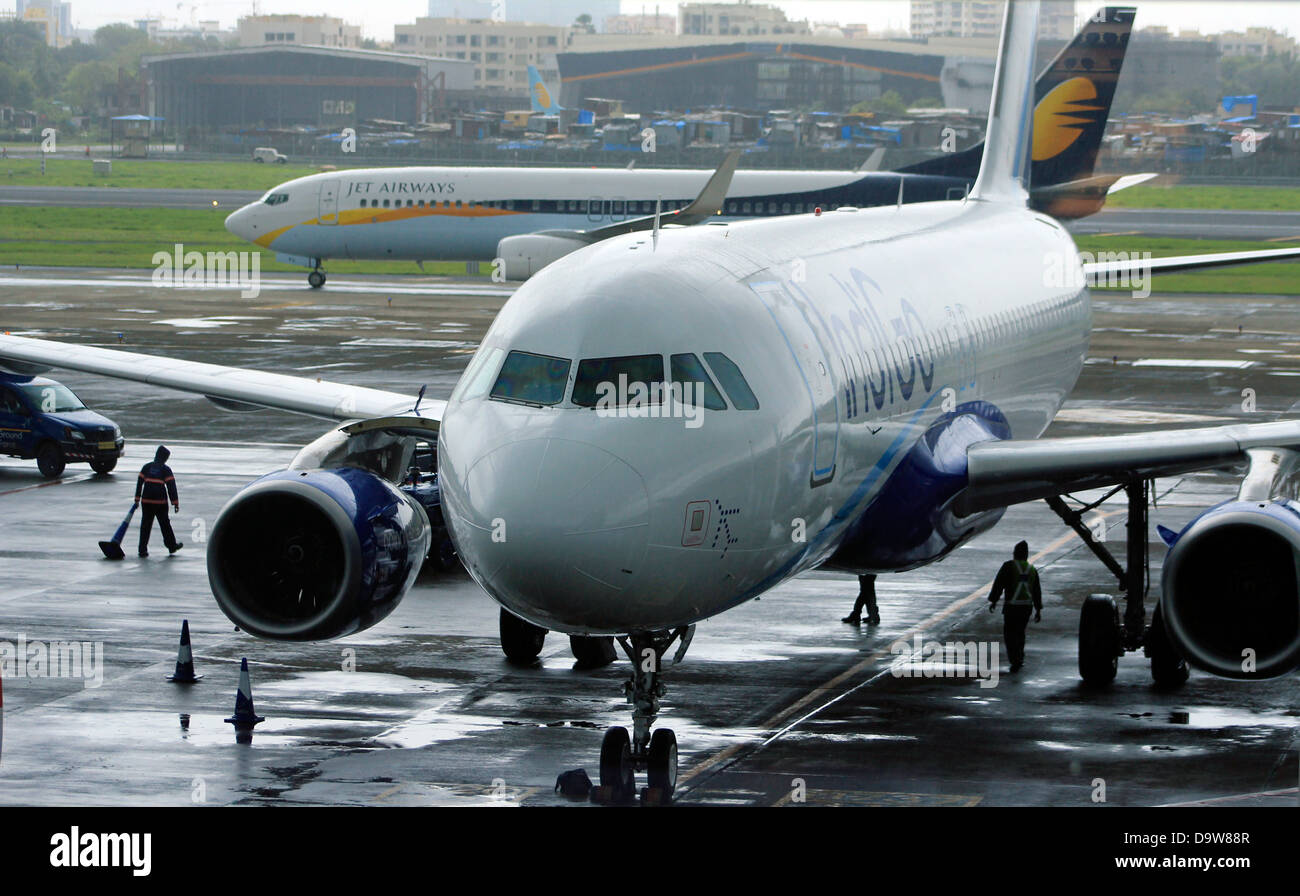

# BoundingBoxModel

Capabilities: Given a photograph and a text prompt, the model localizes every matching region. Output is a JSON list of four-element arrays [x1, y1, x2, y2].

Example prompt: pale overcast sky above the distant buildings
[[27, 0, 1300, 40]]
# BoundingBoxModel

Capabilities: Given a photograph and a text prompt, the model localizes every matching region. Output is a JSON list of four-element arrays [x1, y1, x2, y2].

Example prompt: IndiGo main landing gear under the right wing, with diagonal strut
[[1047, 479, 1188, 688]]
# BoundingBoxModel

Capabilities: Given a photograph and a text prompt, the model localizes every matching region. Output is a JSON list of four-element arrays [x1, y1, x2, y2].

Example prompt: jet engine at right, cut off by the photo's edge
[[1160, 499, 1300, 679]]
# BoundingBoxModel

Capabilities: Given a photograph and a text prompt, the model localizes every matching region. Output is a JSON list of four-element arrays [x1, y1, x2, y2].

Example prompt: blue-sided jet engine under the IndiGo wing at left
[[208, 467, 429, 641]]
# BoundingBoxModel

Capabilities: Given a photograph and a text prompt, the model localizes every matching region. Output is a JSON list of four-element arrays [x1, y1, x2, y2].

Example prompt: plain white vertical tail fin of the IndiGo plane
[[971, 0, 1039, 204]]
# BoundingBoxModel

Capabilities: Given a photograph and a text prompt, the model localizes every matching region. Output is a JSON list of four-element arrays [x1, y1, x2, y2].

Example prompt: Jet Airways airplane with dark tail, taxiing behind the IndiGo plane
[[226, 7, 1154, 287]]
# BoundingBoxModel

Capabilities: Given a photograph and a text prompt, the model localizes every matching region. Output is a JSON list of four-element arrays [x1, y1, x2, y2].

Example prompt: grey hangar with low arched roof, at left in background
[[142, 46, 475, 138]]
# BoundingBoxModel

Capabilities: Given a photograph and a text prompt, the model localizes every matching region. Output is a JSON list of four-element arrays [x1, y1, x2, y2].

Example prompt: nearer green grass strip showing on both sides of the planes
[[0, 207, 1300, 289]]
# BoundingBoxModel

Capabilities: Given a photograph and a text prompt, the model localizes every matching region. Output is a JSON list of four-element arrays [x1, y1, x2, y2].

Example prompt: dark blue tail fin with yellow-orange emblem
[[898, 7, 1138, 197]]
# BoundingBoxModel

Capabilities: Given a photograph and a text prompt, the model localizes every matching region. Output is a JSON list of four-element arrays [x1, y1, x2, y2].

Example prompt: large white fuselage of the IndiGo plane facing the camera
[[439, 202, 1091, 633]]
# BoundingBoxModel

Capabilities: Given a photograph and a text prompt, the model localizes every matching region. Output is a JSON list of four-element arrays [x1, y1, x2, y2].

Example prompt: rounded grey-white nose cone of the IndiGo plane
[[449, 438, 650, 631]]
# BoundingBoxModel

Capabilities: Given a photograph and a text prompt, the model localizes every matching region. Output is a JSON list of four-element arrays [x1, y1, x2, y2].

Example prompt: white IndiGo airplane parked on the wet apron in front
[[0, 3, 1300, 796]]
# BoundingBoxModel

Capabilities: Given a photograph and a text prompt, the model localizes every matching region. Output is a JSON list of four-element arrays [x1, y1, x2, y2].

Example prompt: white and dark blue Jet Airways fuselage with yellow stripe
[[218, 168, 963, 264]]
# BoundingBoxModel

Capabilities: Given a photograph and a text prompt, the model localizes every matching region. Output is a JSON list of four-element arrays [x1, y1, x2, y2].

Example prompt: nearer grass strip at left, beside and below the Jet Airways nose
[[0, 207, 488, 276]]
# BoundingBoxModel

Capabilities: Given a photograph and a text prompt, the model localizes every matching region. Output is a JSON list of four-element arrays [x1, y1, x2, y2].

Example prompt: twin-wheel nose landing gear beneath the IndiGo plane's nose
[[597, 626, 696, 805]]
